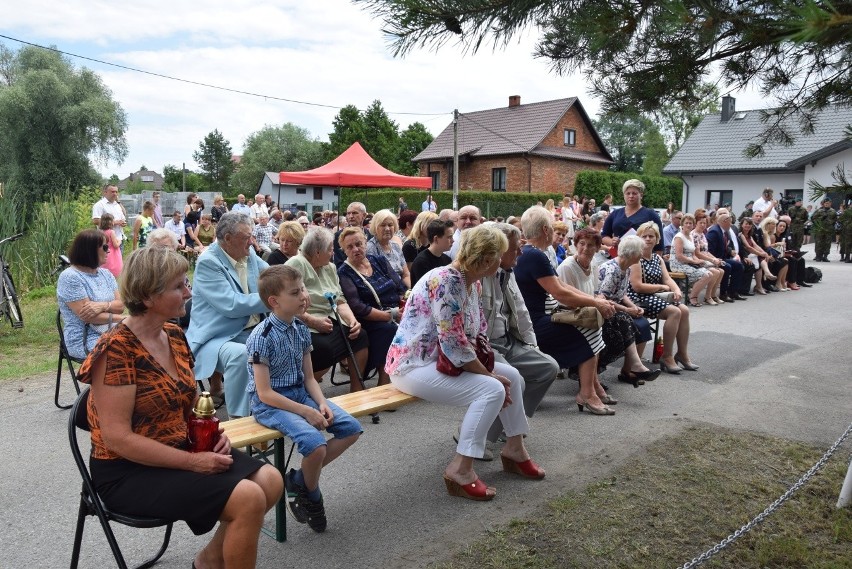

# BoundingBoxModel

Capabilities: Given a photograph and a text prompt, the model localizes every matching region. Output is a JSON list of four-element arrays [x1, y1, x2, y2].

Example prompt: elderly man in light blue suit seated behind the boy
[[186, 212, 269, 417]]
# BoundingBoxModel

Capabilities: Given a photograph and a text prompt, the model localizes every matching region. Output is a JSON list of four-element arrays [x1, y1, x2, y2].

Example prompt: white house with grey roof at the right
[[663, 97, 852, 215]]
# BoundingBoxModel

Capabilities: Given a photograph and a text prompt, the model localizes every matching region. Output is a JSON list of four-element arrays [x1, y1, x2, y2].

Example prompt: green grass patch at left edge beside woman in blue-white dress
[[0, 286, 59, 381]]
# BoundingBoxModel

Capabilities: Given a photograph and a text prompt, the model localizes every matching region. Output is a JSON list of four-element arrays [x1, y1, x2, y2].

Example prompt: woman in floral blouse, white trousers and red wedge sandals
[[385, 224, 549, 500]]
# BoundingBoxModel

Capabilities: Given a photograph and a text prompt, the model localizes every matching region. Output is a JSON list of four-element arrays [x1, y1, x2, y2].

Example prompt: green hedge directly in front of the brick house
[[340, 188, 563, 218]]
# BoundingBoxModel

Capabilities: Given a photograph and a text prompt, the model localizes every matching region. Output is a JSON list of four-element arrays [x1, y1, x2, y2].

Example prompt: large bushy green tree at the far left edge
[[0, 47, 127, 201]]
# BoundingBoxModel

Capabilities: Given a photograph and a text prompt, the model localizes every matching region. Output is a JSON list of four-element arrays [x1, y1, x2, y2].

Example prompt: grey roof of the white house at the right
[[663, 105, 852, 174]]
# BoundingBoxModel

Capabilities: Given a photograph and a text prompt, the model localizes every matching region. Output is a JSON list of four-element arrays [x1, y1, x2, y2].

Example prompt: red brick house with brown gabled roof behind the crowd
[[414, 95, 613, 194]]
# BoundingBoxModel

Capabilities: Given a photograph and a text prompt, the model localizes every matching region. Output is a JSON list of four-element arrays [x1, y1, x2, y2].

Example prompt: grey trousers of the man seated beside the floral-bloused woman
[[487, 334, 559, 442]]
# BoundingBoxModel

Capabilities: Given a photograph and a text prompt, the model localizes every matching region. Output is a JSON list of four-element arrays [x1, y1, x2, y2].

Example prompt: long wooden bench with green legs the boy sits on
[[222, 385, 417, 542]]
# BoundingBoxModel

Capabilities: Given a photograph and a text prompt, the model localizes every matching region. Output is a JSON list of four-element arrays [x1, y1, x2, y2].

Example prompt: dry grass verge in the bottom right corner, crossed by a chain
[[433, 426, 852, 569]]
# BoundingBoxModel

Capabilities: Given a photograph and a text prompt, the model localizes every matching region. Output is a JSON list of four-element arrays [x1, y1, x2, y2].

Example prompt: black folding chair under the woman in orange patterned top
[[68, 389, 173, 569]]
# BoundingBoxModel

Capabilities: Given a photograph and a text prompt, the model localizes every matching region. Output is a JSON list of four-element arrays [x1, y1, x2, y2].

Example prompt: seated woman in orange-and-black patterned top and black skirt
[[79, 247, 283, 569]]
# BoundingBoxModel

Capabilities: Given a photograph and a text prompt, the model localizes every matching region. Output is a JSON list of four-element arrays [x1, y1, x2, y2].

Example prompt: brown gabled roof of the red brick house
[[414, 97, 613, 164]]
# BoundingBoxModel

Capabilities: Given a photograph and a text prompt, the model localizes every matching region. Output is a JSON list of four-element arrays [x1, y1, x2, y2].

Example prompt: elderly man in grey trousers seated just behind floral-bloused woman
[[481, 223, 559, 458]]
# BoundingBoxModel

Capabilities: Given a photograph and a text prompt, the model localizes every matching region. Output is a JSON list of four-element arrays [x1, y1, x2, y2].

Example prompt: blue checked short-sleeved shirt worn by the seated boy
[[246, 314, 313, 393]]
